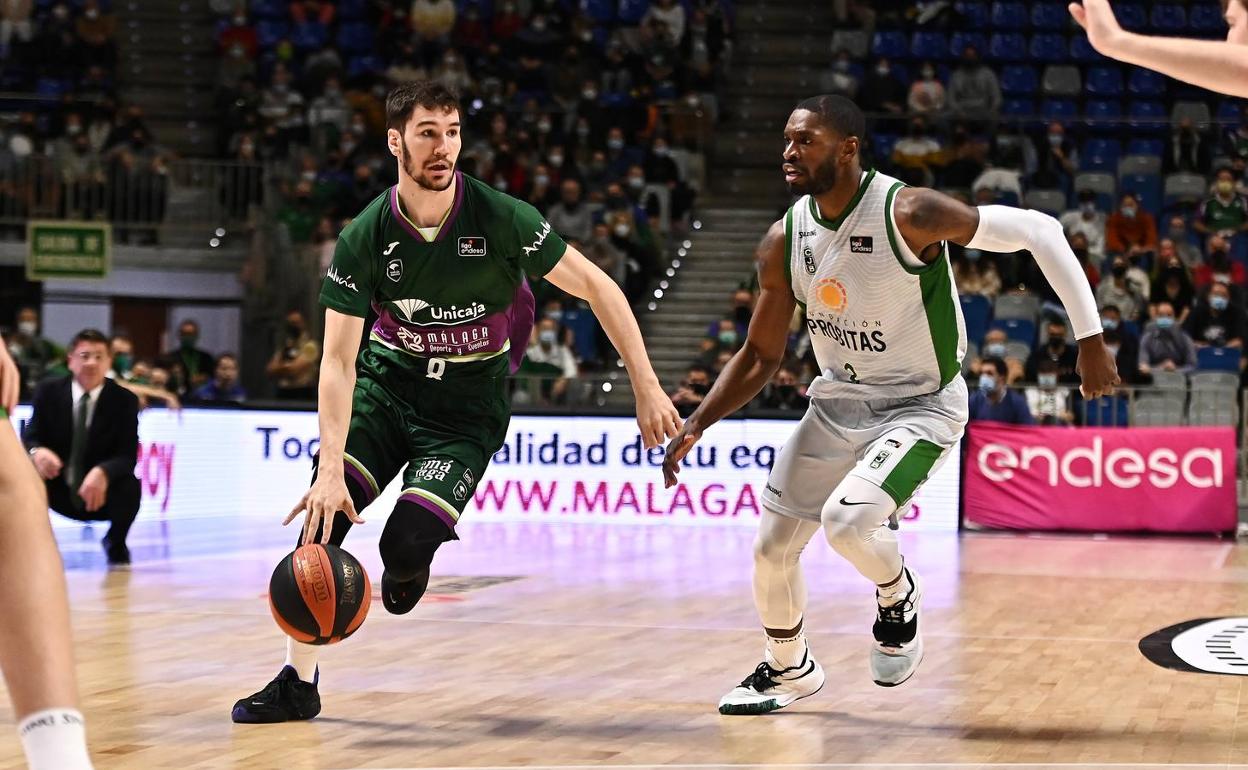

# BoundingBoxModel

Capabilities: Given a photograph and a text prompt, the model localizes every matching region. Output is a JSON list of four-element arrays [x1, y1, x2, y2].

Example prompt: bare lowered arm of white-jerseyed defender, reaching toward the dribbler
[[663, 220, 797, 487]]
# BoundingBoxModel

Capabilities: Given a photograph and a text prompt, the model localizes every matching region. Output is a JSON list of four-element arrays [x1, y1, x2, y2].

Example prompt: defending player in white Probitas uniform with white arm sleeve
[[663, 96, 1118, 714]]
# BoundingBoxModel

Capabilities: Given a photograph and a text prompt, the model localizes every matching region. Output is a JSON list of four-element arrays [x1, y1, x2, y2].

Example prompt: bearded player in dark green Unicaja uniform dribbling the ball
[[233, 81, 680, 723]]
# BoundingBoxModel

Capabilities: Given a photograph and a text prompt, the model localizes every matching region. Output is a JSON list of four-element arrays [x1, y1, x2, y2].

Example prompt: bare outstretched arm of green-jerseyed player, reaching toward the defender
[[545, 246, 680, 449]]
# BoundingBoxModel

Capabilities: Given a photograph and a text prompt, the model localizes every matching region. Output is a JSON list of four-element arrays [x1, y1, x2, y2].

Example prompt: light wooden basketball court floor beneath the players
[[0, 517, 1248, 770]]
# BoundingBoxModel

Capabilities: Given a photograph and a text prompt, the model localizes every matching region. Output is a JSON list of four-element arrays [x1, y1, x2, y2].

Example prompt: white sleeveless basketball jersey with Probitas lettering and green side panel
[[785, 171, 966, 399]]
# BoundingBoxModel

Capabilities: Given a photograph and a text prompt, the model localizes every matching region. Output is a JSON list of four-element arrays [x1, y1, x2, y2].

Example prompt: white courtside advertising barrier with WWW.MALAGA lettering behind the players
[[14, 407, 960, 530]]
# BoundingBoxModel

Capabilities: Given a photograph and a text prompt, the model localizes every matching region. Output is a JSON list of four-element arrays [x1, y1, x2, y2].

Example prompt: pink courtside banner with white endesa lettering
[[963, 422, 1237, 532]]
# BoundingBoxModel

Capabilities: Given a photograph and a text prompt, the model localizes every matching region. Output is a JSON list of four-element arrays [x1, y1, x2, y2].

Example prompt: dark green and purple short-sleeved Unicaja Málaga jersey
[[321, 172, 567, 374]]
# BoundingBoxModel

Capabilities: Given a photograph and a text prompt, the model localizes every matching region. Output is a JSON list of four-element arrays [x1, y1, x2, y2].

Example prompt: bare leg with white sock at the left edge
[[0, 404, 91, 770]]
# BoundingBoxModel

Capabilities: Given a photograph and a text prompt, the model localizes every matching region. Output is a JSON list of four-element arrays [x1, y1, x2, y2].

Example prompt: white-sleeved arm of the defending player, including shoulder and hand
[[895, 187, 1121, 398]]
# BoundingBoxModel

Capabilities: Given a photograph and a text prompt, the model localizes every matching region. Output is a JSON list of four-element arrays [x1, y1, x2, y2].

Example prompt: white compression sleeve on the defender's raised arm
[[966, 206, 1101, 339]]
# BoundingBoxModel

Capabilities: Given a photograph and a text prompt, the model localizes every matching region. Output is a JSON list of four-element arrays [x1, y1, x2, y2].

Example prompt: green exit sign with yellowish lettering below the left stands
[[26, 221, 112, 281]]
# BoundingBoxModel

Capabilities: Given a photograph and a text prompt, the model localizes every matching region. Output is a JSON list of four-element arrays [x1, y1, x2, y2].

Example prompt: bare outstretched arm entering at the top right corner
[[1070, 0, 1248, 96]]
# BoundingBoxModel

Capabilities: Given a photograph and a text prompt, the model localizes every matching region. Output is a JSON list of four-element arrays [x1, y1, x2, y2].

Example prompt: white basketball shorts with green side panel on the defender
[[763, 377, 967, 522]]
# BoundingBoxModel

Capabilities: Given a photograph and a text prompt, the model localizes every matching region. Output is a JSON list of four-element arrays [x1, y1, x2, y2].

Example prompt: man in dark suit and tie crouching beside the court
[[22, 329, 141, 564]]
